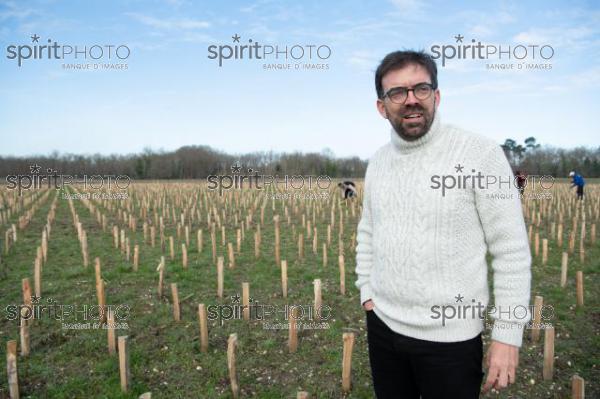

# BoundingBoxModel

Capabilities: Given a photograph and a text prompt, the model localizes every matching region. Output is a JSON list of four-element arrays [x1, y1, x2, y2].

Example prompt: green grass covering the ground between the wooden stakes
[[0, 185, 600, 398]]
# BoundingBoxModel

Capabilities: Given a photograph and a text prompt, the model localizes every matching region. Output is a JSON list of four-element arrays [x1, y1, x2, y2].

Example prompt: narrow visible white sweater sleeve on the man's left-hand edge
[[355, 169, 373, 304]]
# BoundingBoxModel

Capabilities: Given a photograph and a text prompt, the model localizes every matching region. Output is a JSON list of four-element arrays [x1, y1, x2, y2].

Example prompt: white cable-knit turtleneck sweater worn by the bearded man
[[356, 112, 531, 346]]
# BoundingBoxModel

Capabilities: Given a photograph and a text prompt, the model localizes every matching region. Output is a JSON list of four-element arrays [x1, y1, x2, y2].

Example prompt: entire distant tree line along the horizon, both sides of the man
[[0, 137, 600, 179]]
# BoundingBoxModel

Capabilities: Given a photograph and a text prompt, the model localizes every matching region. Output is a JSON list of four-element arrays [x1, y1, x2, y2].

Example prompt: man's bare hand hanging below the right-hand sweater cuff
[[483, 341, 519, 393]]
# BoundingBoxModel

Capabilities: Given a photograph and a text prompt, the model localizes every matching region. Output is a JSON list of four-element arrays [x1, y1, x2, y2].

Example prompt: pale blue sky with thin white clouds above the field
[[0, 0, 600, 158]]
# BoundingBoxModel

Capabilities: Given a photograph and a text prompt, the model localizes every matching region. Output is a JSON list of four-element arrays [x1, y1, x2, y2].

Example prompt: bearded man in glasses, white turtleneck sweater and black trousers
[[356, 51, 531, 399]]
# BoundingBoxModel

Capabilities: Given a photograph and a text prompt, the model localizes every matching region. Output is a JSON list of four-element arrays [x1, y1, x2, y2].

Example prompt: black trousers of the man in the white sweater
[[366, 310, 484, 399]]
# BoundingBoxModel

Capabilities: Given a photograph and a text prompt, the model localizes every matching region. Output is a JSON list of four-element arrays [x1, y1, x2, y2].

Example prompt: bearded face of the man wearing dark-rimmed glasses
[[377, 64, 440, 141]]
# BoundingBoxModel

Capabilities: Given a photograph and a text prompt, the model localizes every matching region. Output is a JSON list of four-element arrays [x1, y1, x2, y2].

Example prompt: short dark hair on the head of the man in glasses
[[375, 50, 437, 98]]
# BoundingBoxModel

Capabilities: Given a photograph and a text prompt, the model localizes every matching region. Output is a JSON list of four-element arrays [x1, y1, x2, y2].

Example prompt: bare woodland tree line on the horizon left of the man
[[0, 146, 367, 179]]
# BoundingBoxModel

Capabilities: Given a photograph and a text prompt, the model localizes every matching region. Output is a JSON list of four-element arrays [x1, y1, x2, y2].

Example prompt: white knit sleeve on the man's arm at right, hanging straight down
[[475, 145, 531, 347]]
